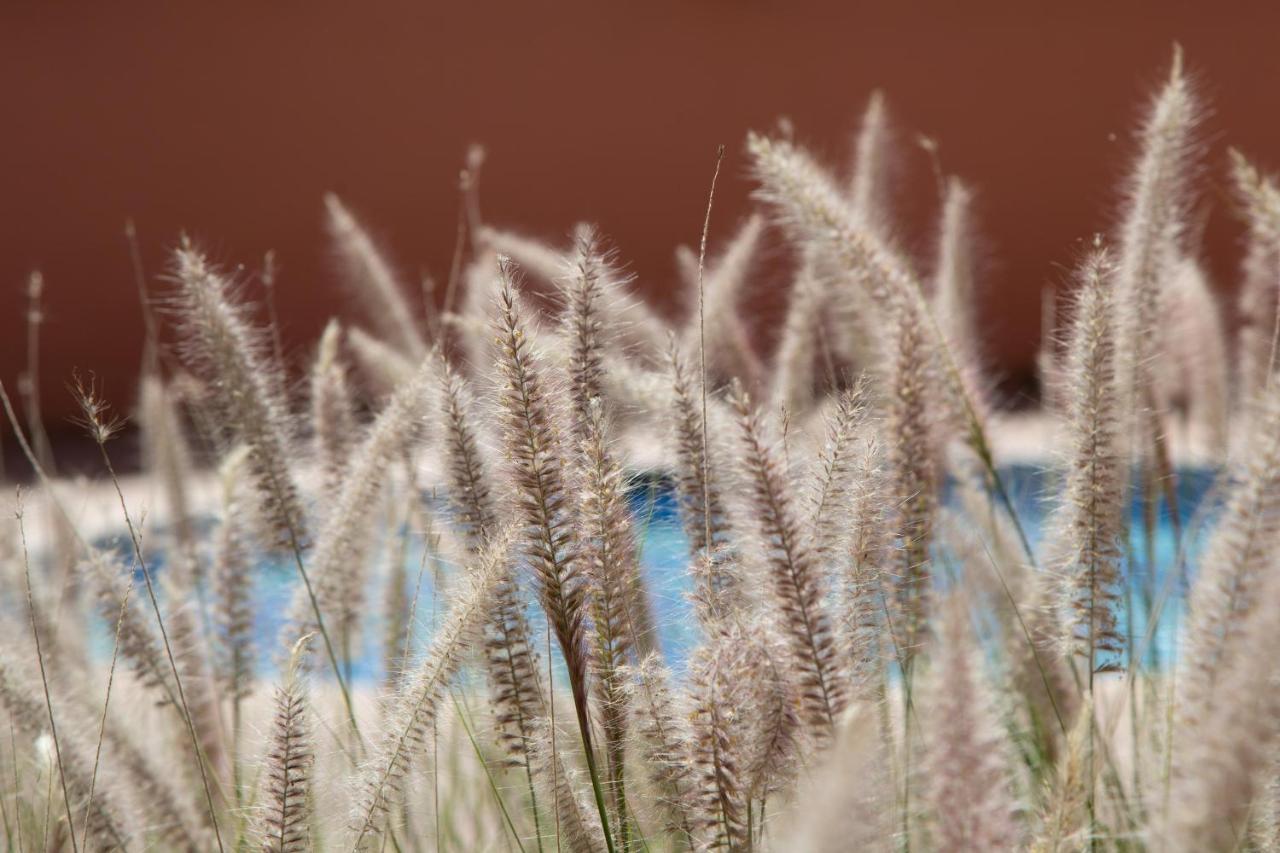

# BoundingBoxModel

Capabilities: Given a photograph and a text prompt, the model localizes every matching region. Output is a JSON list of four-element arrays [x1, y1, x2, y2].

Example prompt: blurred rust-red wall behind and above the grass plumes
[[0, 0, 1280, 470]]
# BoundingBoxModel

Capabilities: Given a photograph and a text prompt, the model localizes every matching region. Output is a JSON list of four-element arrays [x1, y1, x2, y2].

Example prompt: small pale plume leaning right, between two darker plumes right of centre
[[805, 380, 868, 564]]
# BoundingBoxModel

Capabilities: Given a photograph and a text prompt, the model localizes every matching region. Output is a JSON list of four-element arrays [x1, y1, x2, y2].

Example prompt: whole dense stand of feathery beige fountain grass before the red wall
[[0, 44, 1280, 853]]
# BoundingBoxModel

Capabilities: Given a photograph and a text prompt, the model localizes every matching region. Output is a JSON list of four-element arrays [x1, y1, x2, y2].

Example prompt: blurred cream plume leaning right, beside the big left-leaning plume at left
[[291, 356, 435, 647]]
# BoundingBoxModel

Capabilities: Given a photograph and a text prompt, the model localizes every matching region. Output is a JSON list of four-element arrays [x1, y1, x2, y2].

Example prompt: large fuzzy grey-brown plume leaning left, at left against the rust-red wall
[[167, 241, 306, 544]]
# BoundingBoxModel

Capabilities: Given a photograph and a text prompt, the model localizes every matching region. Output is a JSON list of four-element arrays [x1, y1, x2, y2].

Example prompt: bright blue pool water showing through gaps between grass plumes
[[96, 465, 1213, 680]]
